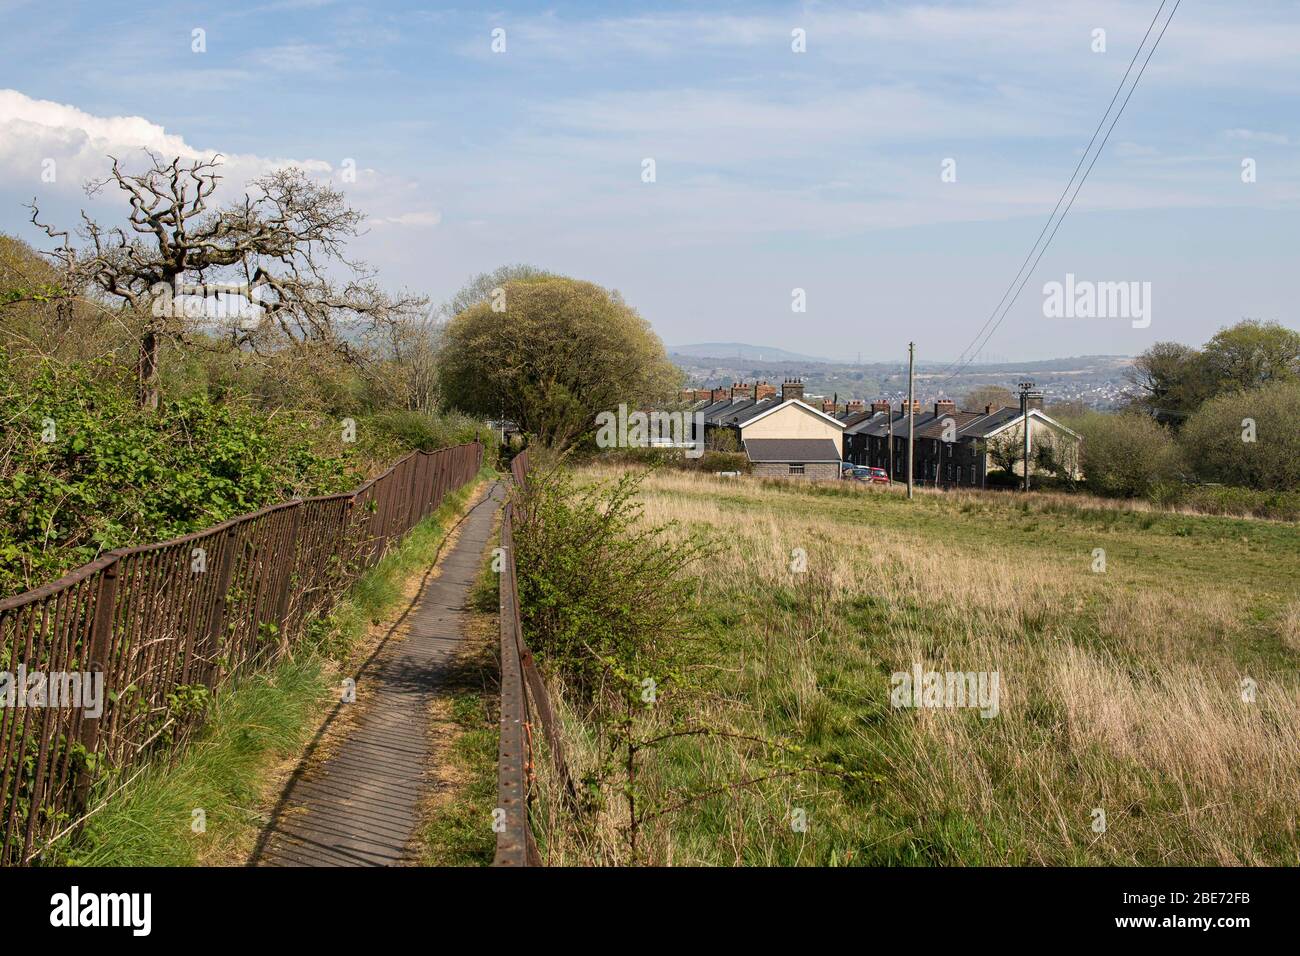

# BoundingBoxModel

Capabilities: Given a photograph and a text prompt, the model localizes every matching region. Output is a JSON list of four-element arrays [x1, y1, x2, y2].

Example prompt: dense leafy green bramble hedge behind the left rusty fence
[[0, 352, 360, 593]]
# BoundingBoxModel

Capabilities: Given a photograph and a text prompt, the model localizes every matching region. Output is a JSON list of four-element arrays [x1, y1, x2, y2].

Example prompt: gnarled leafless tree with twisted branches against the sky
[[30, 151, 428, 408]]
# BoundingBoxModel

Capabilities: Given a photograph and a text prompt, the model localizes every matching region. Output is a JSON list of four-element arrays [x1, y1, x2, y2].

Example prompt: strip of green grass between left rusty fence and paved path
[[54, 468, 493, 866]]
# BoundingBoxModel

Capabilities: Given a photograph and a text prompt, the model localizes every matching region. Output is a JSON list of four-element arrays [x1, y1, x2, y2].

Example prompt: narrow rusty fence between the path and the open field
[[493, 450, 577, 866]]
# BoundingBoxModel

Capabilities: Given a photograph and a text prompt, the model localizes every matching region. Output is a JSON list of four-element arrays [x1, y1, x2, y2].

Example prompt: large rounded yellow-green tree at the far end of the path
[[438, 276, 681, 449]]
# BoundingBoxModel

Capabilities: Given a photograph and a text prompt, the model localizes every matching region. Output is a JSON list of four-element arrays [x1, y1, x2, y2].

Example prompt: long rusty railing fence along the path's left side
[[0, 442, 484, 865]]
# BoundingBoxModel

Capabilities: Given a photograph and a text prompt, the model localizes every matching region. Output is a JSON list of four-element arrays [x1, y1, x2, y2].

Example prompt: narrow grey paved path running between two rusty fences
[[252, 484, 503, 866]]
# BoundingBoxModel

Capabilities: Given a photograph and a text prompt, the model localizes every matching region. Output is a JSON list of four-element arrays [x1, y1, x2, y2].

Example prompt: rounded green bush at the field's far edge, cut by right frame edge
[[1180, 381, 1300, 490]]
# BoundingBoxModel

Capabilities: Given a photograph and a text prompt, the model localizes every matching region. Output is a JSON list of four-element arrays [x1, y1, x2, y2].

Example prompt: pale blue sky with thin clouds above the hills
[[0, 0, 1300, 362]]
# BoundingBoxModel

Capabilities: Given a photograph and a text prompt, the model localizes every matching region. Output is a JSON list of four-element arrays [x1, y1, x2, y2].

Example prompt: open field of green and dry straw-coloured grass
[[546, 467, 1300, 865]]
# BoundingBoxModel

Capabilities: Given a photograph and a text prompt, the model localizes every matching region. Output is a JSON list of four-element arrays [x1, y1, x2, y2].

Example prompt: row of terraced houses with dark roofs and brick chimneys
[[681, 380, 1079, 488]]
